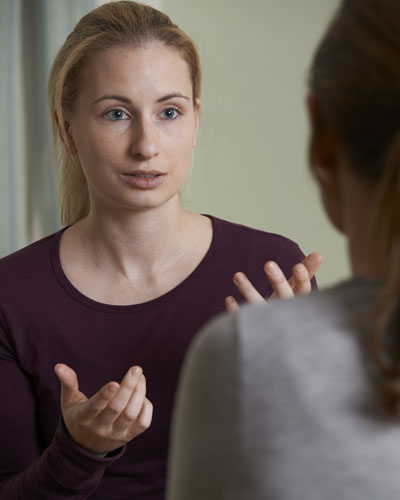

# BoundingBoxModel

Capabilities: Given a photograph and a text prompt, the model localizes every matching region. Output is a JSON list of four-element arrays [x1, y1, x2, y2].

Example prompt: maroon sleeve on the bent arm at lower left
[[0, 318, 123, 500]]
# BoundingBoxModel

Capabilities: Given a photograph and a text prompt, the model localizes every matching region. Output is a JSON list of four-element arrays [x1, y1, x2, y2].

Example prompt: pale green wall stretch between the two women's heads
[[162, 0, 349, 285]]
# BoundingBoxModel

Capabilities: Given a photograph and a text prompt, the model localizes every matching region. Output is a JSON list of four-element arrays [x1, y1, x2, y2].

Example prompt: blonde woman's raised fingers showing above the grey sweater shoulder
[[225, 252, 322, 312]]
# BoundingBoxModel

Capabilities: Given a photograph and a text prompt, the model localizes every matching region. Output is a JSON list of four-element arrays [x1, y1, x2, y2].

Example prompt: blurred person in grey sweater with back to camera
[[167, 0, 400, 500]]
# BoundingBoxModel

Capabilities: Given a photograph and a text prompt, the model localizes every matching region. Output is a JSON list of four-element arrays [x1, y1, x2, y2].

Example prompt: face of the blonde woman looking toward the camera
[[67, 42, 199, 215]]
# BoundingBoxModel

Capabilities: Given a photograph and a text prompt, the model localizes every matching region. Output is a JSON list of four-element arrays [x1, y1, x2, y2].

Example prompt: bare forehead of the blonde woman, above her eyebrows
[[79, 42, 192, 98]]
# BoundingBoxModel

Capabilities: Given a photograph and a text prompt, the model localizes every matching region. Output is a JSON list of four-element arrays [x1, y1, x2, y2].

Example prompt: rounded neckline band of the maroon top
[[50, 214, 220, 314]]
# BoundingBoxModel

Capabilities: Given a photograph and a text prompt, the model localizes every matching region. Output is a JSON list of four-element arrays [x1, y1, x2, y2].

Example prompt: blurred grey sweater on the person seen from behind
[[167, 278, 400, 500]]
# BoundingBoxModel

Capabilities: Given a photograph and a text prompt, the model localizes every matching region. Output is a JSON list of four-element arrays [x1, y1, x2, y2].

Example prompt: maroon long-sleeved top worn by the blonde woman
[[0, 217, 312, 500]]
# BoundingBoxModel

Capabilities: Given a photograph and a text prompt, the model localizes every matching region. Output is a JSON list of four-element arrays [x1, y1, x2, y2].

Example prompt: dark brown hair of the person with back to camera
[[310, 0, 400, 410]]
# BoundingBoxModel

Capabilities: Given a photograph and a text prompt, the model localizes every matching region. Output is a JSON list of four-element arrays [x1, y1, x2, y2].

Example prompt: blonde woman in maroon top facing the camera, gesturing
[[0, 1, 319, 500]]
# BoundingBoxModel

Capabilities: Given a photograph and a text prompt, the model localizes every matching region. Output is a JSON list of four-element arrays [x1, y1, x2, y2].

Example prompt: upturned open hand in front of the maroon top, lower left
[[54, 363, 153, 455]]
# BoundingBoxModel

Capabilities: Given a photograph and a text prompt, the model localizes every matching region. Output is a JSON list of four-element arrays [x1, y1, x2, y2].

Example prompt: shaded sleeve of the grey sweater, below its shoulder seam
[[167, 316, 240, 500]]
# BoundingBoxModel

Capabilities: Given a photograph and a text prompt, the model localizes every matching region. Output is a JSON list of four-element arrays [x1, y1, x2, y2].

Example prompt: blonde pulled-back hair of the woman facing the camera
[[47, 1, 201, 225]]
